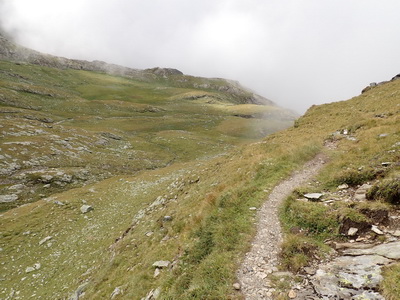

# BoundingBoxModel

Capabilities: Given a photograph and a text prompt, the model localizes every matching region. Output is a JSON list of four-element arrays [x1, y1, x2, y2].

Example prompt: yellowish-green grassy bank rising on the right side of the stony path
[[281, 81, 400, 299]]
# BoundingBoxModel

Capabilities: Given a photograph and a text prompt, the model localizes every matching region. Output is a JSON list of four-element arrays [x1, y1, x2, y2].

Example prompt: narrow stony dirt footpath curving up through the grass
[[237, 154, 325, 300]]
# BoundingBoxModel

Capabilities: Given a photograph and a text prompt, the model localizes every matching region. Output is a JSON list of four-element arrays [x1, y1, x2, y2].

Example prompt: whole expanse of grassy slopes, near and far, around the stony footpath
[[0, 45, 400, 299]]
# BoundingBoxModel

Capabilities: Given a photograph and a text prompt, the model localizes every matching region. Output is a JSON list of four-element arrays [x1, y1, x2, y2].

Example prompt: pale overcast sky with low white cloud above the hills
[[0, 0, 400, 113]]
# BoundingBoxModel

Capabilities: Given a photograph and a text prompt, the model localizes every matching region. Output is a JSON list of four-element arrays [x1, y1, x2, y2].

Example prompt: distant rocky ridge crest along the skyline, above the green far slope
[[0, 33, 282, 106]]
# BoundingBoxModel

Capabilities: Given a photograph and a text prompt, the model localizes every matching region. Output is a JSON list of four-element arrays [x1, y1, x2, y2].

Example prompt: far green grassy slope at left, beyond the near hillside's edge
[[0, 61, 294, 210]]
